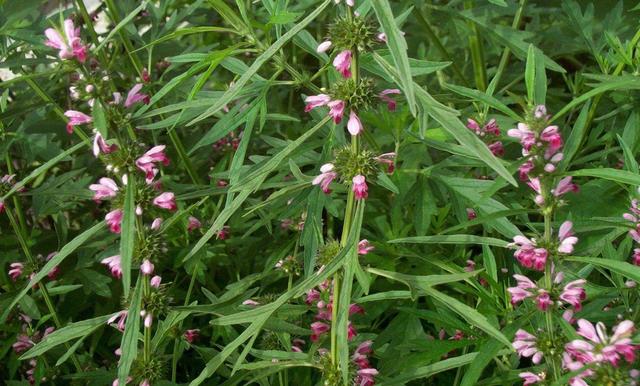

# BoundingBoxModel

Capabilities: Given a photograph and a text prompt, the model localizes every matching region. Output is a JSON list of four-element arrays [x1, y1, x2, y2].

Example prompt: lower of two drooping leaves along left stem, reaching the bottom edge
[[118, 277, 142, 385]]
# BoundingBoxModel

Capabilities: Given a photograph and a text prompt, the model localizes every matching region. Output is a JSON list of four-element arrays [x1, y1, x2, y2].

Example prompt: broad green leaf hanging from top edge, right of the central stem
[[371, 0, 418, 116]]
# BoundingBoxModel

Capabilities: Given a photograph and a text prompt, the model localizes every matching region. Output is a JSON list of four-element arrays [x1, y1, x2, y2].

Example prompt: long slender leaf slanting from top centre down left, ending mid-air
[[189, 0, 331, 125]]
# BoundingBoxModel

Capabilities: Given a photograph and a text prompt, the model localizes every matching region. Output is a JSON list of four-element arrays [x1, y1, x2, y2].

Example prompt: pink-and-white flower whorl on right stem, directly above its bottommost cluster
[[507, 272, 587, 315]]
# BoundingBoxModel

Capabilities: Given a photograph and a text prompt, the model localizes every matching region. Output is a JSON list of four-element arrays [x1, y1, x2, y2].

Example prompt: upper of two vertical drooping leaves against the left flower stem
[[120, 178, 136, 298]]
